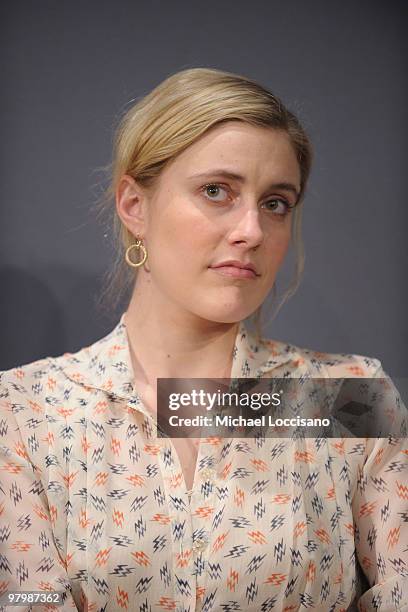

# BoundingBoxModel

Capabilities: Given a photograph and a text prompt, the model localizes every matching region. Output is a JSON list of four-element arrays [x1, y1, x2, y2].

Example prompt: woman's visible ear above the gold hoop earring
[[115, 174, 147, 237]]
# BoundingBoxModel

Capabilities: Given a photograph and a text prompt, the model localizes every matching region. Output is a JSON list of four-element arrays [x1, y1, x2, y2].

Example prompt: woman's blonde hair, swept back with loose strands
[[96, 68, 312, 338]]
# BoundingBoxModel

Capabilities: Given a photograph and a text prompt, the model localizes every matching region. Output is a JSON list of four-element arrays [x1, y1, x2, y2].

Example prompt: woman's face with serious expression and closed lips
[[124, 121, 300, 323]]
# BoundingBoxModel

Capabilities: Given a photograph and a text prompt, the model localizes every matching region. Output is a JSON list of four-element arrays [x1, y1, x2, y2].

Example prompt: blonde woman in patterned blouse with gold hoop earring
[[1, 69, 408, 612]]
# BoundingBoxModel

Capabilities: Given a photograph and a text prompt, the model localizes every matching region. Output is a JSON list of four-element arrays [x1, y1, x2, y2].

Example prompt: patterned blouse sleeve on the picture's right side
[[352, 364, 408, 612]]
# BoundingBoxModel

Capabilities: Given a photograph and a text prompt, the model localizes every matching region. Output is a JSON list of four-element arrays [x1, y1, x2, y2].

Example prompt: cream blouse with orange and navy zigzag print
[[0, 313, 408, 612]]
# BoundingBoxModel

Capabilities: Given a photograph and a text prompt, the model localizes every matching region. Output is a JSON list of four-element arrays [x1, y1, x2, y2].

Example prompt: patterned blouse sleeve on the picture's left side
[[0, 376, 77, 612]]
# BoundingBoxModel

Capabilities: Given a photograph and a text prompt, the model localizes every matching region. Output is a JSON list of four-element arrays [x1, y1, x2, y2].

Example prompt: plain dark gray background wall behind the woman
[[0, 0, 407, 376]]
